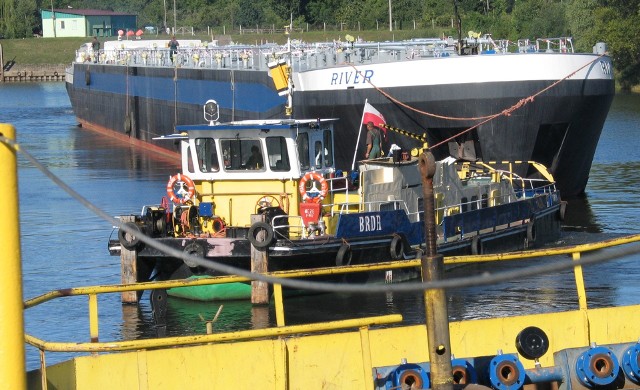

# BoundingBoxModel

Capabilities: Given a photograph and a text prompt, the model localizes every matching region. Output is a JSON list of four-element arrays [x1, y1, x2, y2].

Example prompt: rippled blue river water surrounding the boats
[[0, 83, 640, 369]]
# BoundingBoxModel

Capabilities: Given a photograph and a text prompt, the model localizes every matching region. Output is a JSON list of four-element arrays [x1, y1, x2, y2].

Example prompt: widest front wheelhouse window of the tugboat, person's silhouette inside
[[220, 138, 264, 171]]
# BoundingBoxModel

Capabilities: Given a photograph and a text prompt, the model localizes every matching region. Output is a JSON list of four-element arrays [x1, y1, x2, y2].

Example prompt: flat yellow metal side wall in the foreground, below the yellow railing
[[29, 306, 640, 389]]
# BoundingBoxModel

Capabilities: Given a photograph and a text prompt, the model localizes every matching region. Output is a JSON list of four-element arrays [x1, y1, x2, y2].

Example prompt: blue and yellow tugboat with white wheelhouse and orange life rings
[[109, 101, 564, 299]]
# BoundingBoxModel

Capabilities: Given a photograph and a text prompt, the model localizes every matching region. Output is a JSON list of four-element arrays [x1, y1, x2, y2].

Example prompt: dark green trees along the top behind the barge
[[0, 0, 640, 89]]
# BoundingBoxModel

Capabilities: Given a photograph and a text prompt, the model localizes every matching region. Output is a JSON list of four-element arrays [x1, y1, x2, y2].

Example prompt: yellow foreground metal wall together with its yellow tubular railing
[[25, 235, 640, 390]]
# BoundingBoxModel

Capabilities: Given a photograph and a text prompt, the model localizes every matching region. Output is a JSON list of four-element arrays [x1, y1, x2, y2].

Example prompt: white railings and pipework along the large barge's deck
[[75, 38, 573, 71]]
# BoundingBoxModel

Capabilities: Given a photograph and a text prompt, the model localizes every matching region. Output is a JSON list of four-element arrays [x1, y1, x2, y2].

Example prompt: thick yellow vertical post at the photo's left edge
[[0, 123, 27, 389]]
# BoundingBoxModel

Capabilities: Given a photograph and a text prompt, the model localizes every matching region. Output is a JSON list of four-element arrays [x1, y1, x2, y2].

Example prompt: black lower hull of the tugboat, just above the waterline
[[130, 205, 561, 282]]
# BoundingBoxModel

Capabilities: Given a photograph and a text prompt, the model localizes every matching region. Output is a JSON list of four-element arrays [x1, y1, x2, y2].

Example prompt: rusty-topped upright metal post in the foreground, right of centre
[[418, 152, 453, 390]]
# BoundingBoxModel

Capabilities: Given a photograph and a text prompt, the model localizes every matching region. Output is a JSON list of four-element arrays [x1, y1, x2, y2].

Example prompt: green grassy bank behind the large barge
[[0, 30, 434, 65]]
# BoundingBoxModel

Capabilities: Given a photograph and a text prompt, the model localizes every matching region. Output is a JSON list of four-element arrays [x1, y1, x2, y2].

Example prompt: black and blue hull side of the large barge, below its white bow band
[[67, 64, 614, 197]]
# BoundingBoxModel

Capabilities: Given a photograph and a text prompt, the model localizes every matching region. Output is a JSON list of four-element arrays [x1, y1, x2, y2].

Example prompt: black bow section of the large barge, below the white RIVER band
[[294, 80, 614, 197]]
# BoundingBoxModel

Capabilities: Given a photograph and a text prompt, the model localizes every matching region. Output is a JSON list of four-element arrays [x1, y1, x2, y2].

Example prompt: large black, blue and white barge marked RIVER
[[66, 37, 614, 196]]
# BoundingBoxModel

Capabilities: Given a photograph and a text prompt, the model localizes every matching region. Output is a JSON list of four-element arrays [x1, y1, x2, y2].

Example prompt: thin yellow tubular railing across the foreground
[[24, 234, 640, 352]]
